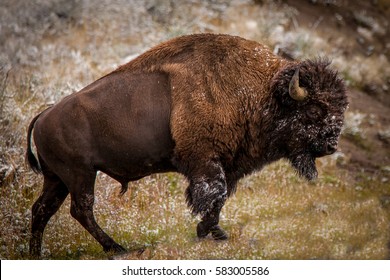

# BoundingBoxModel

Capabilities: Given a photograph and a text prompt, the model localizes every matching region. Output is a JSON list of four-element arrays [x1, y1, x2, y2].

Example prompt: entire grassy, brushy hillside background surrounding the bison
[[0, 0, 390, 259]]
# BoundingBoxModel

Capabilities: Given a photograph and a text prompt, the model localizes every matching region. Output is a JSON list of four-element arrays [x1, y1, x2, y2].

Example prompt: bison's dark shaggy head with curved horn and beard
[[272, 59, 348, 180]]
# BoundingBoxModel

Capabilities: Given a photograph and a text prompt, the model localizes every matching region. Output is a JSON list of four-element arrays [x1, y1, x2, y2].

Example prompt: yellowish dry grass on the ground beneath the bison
[[1, 161, 389, 259]]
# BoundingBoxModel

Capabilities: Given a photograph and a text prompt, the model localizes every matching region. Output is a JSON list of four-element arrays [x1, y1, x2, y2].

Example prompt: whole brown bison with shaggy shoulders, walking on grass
[[26, 34, 348, 257]]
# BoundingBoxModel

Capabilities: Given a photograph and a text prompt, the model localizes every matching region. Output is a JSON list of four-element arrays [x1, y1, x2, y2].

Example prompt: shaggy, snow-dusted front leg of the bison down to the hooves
[[186, 161, 227, 240]]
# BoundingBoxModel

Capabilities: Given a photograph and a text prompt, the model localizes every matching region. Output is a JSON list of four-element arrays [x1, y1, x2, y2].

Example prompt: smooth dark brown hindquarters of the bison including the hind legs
[[30, 73, 176, 255]]
